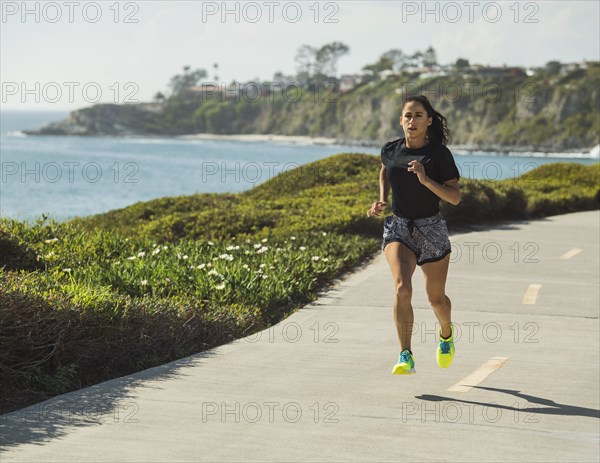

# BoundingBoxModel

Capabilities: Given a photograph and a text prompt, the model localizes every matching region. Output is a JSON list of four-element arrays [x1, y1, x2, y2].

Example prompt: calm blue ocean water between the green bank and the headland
[[0, 110, 598, 220]]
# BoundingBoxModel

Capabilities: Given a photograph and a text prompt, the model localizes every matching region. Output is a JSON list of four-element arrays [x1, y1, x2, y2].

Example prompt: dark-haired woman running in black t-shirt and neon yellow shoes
[[367, 95, 460, 375]]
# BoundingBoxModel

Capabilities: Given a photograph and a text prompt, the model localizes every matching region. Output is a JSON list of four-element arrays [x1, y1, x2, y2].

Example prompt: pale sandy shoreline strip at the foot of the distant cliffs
[[175, 133, 600, 159]]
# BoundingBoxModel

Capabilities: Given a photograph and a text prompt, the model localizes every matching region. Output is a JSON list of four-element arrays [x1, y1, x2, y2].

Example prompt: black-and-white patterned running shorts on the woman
[[381, 214, 452, 265]]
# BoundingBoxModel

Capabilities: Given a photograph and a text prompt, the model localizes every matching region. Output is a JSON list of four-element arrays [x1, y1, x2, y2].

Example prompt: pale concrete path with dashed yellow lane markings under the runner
[[0, 211, 600, 463]]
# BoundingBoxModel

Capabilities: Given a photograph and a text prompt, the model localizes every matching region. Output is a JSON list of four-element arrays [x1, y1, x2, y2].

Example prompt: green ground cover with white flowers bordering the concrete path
[[0, 153, 600, 413]]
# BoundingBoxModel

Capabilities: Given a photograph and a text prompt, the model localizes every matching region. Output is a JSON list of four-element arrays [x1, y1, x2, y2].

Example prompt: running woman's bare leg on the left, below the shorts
[[384, 242, 417, 352]]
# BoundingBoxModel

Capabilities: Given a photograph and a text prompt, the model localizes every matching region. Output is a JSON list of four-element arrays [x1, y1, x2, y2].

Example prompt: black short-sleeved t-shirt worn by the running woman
[[381, 138, 460, 219]]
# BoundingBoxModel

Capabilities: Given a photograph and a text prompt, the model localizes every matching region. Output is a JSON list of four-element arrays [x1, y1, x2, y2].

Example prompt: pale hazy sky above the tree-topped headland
[[0, 0, 600, 110]]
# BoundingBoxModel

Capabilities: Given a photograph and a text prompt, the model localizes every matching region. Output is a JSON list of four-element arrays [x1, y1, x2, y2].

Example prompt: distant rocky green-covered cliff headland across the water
[[26, 62, 600, 151]]
